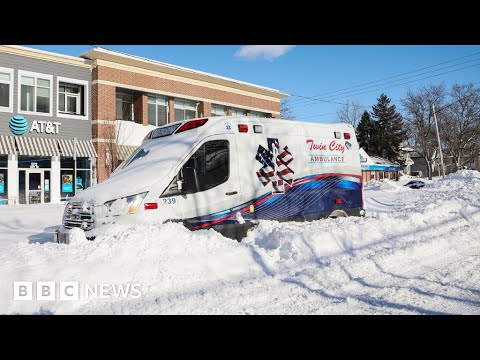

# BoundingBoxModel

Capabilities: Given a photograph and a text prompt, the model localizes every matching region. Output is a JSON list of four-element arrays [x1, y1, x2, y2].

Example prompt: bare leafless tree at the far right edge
[[437, 84, 480, 170]]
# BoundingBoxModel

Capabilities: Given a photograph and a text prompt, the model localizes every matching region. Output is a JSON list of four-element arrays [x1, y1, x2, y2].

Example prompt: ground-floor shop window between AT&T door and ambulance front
[[60, 157, 91, 201]]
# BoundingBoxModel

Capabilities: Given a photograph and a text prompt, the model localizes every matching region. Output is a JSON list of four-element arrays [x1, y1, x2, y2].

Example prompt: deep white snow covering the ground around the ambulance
[[0, 171, 480, 314]]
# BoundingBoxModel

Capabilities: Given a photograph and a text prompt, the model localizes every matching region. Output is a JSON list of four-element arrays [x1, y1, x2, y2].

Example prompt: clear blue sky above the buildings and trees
[[25, 45, 480, 122]]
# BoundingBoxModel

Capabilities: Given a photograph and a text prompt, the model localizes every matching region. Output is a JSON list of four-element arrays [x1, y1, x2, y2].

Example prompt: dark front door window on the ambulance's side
[[161, 140, 230, 197]]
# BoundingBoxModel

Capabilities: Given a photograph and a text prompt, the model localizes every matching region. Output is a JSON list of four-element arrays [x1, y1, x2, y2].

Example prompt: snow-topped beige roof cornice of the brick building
[[80, 47, 288, 99]]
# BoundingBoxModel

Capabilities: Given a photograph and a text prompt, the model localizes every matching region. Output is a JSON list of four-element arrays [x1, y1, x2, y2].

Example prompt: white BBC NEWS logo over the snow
[[13, 281, 142, 301]]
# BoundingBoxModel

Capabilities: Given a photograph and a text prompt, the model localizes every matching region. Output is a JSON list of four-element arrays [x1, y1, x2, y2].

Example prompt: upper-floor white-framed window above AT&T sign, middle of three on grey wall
[[18, 70, 53, 115]]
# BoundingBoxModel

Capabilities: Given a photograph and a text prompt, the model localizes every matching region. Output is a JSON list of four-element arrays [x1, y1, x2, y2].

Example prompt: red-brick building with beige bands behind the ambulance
[[81, 48, 287, 182]]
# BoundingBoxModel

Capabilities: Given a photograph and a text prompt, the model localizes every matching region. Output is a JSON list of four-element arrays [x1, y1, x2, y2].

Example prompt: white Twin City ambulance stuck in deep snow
[[56, 116, 365, 242]]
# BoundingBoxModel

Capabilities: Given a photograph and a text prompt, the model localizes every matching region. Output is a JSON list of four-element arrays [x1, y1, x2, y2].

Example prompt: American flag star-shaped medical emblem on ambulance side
[[255, 138, 294, 193]]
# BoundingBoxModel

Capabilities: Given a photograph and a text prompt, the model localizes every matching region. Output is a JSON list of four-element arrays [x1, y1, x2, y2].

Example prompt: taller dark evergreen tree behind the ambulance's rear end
[[369, 94, 406, 161]]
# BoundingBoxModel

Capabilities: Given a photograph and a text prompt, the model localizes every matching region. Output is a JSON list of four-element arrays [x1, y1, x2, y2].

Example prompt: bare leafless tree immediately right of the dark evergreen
[[402, 84, 446, 179]]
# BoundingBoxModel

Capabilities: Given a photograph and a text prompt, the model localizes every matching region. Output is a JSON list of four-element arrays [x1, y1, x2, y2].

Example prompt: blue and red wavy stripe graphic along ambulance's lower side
[[187, 174, 363, 229]]
